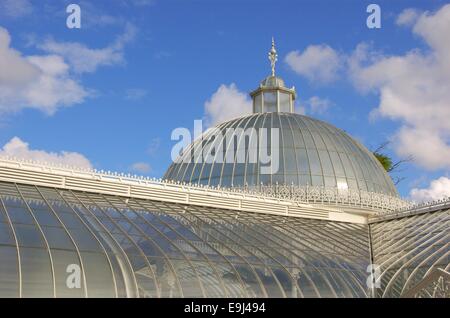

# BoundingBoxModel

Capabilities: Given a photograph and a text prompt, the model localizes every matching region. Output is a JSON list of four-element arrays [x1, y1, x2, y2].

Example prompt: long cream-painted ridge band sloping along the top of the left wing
[[0, 159, 380, 223]]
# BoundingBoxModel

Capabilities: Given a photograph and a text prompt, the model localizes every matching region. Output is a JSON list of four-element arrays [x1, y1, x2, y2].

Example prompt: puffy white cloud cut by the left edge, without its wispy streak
[[0, 27, 88, 114]]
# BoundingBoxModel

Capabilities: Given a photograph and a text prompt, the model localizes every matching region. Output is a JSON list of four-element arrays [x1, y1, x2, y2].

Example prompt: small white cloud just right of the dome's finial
[[285, 44, 342, 84]]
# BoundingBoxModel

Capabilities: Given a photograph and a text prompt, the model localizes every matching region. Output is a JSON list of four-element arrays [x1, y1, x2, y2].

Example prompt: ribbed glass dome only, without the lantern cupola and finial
[[164, 112, 398, 196]]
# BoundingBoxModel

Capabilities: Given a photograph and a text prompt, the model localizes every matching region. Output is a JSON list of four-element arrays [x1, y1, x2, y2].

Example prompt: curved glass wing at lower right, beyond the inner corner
[[369, 201, 450, 298]]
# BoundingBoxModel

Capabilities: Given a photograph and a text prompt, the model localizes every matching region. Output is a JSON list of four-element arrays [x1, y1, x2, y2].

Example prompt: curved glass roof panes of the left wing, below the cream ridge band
[[0, 183, 370, 297]]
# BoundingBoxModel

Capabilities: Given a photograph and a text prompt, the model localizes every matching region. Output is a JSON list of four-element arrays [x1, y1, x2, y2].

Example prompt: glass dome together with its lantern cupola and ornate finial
[[164, 38, 398, 197]]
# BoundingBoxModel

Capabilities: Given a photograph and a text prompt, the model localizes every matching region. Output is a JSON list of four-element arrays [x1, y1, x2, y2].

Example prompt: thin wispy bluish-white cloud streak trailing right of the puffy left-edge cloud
[[38, 24, 136, 74]]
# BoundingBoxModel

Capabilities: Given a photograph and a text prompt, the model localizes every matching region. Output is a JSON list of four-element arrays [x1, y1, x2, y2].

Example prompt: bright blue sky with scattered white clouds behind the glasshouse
[[0, 0, 450, 200]]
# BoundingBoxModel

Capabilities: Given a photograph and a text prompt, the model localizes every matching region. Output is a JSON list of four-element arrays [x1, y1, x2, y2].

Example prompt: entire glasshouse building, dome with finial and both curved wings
[[0, 43, 450, 298]]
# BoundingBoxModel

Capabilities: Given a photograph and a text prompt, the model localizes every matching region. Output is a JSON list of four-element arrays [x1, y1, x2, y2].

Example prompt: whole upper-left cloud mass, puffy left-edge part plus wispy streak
[[0, 24, 136, 115]]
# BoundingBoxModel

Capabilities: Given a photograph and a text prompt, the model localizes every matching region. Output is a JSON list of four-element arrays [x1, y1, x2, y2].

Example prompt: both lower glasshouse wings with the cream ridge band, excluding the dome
[[0, 160, 450, 297]]
